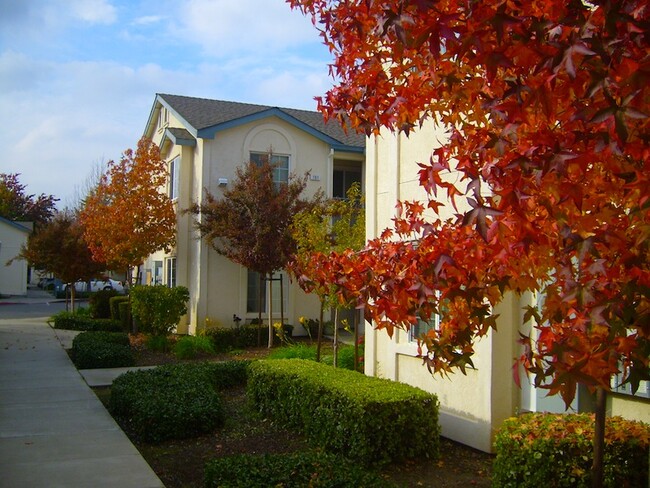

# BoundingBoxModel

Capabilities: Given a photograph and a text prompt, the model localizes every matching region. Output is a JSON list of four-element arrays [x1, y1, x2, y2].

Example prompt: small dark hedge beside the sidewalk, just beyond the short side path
[[71, 332, 135, 369]]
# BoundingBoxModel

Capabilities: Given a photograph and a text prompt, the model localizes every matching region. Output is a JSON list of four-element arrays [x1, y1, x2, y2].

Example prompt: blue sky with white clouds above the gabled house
[[0, 0, 332, 209]]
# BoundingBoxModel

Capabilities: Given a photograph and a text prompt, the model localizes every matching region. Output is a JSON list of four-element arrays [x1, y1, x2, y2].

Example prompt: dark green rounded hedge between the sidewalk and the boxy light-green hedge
[[109, 361, 249, 442]]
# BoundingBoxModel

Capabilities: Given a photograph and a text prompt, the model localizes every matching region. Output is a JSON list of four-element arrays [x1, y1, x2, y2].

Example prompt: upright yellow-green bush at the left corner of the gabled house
[[131, 285, 190, 335]]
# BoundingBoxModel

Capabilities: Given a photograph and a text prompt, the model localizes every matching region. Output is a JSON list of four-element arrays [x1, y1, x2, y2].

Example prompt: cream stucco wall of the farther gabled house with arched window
[[146, 107, 363, 334]]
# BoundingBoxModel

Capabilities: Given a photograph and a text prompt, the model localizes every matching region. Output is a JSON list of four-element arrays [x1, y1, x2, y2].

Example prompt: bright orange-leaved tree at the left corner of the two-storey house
[[80, 137, 176, 277]]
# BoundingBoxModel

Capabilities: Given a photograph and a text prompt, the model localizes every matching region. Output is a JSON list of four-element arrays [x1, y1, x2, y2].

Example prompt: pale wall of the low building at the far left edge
[[0, 220, 28, 295]]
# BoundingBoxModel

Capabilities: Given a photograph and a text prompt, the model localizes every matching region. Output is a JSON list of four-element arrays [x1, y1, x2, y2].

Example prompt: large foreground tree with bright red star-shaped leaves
[[290, 0, 650, 486]]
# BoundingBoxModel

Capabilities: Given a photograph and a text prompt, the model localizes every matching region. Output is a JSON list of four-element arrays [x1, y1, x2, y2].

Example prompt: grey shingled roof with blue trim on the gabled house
[[157, 94, 365, 151]]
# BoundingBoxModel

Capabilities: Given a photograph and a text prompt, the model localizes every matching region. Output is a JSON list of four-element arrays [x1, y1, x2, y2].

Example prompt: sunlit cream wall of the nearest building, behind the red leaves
[[365, 122, 521, 452]]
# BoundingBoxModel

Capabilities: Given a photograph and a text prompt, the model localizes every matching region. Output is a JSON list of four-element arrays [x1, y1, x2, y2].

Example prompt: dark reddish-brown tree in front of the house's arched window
[[188, 156, 321, 347]]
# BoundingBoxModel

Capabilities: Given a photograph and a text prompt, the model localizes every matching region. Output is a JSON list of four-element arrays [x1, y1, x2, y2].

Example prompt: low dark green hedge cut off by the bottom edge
[[205, 452, 396, 488]]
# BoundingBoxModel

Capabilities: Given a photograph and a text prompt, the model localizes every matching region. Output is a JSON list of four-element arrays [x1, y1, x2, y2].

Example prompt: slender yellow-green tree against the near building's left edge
[[289, 183, 366, 370]]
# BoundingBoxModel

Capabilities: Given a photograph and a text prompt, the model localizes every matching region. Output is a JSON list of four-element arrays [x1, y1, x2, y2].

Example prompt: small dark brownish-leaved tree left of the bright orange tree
[[19, 212, 106, 311]]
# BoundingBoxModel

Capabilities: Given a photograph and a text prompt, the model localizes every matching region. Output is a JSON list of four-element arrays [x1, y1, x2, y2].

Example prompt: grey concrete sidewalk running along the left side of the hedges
[[0, 319, 164, 488]]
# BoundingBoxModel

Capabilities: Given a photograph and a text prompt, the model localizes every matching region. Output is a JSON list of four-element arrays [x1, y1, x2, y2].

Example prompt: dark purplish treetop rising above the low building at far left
[[0, 173, 59, 224]]
